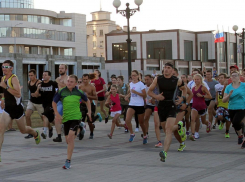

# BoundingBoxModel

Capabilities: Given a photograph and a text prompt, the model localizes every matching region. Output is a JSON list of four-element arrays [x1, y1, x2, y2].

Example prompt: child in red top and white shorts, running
[[105, 85, 127, 139]]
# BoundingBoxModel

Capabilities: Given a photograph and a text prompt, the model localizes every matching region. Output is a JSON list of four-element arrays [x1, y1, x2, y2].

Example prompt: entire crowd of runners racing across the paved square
[[0, 60, 245, 169]]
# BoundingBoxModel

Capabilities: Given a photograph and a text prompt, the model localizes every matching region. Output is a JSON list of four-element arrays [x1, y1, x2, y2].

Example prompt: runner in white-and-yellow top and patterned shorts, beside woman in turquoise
[[215, 73, 231, 138]]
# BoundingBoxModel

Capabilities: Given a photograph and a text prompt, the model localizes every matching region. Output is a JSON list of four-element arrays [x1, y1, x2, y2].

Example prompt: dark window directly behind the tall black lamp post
[[112, 42, 137, 60]]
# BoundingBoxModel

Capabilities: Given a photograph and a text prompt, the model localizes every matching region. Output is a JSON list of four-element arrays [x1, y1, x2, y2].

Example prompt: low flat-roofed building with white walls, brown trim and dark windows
[[106, 29, 242, 74]]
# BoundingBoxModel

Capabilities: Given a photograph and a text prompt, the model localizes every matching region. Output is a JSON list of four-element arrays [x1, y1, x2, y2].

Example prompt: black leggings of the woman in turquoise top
[[229, 109, 245, 131]]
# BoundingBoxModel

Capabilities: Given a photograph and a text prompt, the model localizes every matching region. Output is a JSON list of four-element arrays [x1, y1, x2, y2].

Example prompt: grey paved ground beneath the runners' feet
[[0, 117, 245, 182]]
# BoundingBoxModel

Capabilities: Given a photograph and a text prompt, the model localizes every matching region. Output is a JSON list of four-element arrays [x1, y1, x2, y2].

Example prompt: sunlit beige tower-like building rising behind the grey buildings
[[87, 11, 119, 57]]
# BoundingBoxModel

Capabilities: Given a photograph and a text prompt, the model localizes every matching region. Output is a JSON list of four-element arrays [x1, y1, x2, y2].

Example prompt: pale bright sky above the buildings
[[34, 0, 245, 32]]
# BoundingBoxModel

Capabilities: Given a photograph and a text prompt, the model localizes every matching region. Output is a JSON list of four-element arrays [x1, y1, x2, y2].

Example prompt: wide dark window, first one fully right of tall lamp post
[[146, 40, 172, 59]]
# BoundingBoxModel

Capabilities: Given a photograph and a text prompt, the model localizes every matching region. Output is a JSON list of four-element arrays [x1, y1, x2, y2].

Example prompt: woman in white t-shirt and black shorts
[[125, 70, 147, 144]]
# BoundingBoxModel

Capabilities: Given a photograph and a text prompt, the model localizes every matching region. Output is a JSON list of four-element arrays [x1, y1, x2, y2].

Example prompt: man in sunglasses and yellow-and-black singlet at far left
[[0, 60, 41, 162]]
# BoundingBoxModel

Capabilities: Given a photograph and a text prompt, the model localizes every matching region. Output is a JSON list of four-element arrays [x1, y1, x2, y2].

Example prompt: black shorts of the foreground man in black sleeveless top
[[158, 101, 176, 122]]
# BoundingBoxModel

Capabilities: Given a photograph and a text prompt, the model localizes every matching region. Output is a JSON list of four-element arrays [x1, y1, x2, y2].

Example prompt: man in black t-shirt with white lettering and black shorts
[[35, 71, 58, 139]]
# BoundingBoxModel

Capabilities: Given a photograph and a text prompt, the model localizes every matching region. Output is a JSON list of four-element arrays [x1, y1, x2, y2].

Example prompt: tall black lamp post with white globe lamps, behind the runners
[[113, 0, 143, 77]]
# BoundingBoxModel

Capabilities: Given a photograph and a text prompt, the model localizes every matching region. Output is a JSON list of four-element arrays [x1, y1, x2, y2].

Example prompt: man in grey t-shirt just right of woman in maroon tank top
[[205, 70, 219, 126]]
